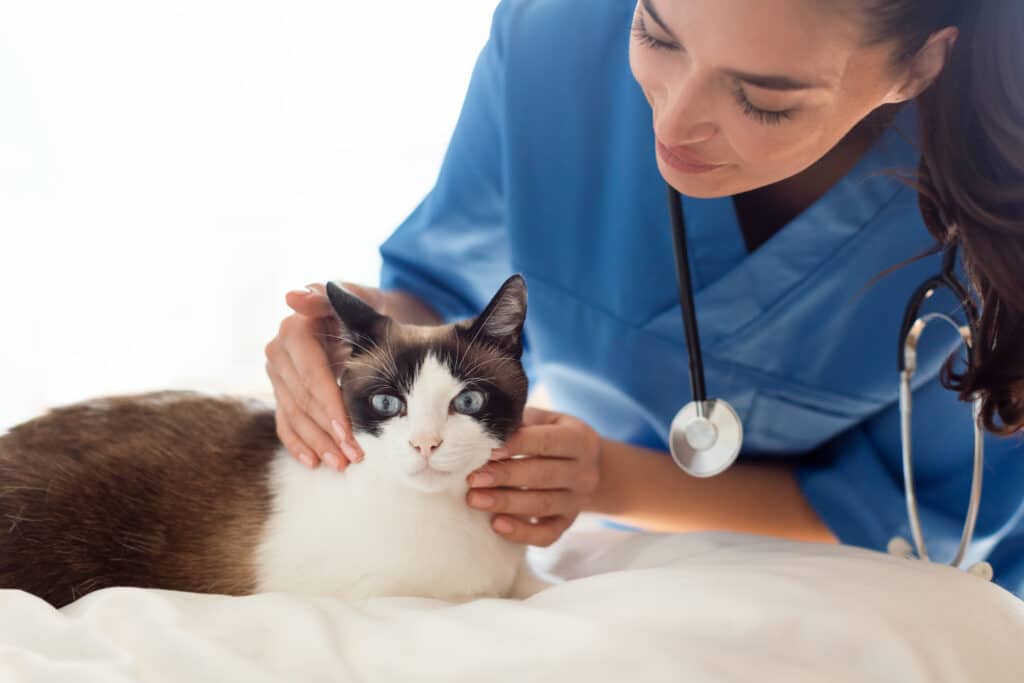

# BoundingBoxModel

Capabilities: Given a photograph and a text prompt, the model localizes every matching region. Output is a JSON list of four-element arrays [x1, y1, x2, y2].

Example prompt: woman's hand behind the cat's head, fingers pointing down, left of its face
[[264, 283, 384, 471]]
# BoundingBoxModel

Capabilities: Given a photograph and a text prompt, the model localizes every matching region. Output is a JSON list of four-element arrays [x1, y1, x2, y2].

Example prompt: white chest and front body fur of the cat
[[255, 451, 524, 600]]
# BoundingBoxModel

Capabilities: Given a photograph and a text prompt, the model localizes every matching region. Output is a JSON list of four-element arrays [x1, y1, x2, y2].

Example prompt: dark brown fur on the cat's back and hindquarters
[[0, 392, 281, 606]]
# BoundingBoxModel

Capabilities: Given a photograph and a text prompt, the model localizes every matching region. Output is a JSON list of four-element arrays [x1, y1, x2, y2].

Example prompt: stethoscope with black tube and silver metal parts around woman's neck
[[668, 185, 992, 580]]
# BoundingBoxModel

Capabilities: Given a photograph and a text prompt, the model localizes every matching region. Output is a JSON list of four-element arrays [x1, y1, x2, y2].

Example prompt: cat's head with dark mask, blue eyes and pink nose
[[328, 276, 526, 492]]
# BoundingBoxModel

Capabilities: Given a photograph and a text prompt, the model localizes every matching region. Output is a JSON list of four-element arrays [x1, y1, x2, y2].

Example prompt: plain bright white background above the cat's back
[[0, 0, 497, 431]]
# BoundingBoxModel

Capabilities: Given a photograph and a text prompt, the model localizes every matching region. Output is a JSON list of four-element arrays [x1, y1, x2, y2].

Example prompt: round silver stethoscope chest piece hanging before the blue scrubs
[[669, 398, 743, 477]]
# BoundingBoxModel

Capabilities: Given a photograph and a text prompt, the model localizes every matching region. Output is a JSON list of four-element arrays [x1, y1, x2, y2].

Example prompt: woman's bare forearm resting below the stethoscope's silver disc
[[590, 439, 837, 543]]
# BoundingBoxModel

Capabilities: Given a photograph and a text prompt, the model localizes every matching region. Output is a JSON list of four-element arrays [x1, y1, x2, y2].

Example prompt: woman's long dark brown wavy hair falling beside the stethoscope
[[859, 0, 1024, 434]]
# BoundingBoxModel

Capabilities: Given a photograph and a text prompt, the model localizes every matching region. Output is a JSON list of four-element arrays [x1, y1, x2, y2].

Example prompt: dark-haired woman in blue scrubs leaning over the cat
[[266, 0, 1024, 594]]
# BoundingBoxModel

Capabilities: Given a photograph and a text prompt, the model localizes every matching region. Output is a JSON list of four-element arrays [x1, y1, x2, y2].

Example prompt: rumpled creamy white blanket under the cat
[[0, 530, 1024, 683]]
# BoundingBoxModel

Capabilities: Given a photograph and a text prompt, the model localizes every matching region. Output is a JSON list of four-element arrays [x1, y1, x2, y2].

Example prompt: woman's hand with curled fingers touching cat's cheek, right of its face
[[466, 408, 601, 546]]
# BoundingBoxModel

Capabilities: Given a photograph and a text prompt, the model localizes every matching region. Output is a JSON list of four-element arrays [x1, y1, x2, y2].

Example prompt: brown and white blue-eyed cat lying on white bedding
[[0, 275, 548, 607]]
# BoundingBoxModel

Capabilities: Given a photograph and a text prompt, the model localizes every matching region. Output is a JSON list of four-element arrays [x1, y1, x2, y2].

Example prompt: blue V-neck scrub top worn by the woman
[[381, 0, 1024, 595]]
